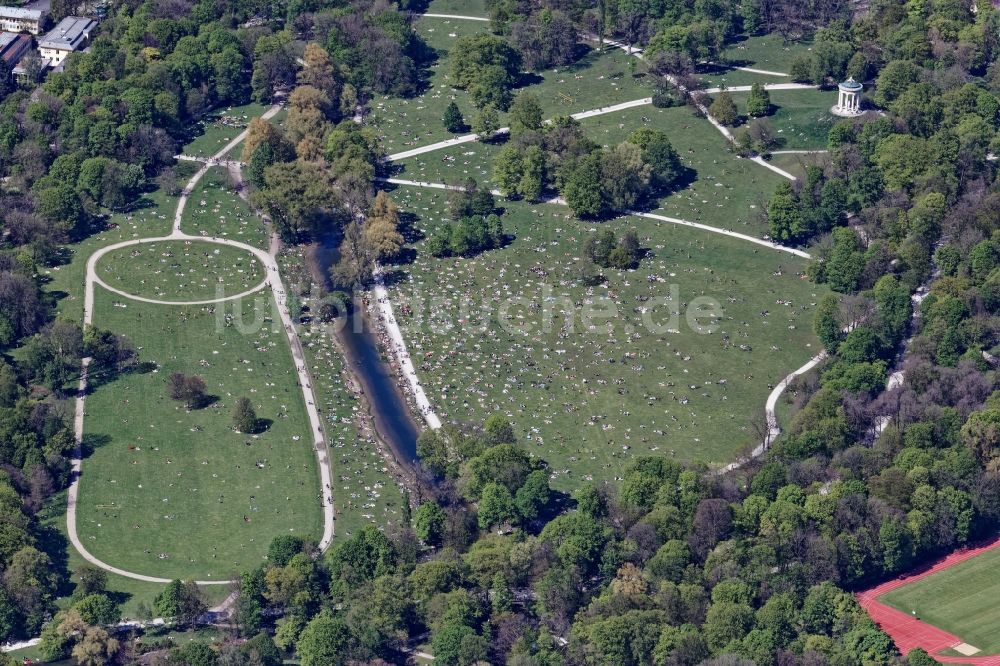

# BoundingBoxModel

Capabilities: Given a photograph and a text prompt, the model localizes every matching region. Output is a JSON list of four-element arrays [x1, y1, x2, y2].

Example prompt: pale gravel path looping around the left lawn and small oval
[[66, 105, 334, 584]]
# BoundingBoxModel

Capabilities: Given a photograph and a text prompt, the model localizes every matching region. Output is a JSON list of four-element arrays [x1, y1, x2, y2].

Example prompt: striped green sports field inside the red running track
[[880, 549, 1000, 654]]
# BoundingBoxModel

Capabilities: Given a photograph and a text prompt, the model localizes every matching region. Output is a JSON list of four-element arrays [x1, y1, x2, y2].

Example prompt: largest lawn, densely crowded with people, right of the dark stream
[[382, 188, 823, 489]]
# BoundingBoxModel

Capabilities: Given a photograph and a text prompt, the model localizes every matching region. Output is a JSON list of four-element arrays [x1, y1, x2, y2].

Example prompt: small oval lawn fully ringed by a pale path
[[97, 240, 264, 305]]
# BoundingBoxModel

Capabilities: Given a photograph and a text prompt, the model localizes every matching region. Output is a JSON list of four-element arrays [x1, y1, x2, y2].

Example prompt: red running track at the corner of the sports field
[[855, 537, 1000, 666]]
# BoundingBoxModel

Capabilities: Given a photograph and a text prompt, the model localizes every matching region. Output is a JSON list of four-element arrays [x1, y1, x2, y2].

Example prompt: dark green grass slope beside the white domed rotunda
[[720, 90, 837, 150]]
